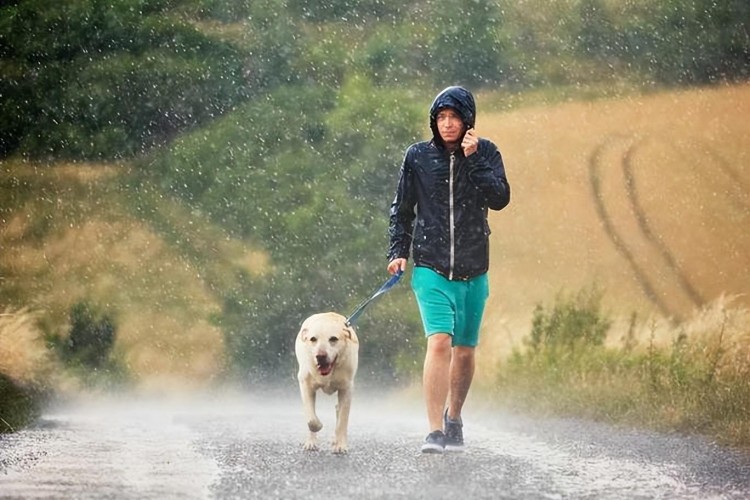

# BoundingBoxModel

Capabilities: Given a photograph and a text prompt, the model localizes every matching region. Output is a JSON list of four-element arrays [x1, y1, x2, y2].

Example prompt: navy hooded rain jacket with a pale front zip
[[388, 87, 510, 280]]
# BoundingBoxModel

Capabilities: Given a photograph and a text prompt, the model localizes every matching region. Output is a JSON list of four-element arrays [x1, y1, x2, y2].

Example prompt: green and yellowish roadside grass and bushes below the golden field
[[497, 292, 750, 446]]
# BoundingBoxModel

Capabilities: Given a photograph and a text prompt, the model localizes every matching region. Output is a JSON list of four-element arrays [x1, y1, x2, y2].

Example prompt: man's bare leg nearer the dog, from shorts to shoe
[[422, 333, 452, 432]]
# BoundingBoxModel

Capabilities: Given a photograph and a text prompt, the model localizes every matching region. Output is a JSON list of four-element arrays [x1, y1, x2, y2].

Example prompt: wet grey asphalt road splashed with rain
[[0, 387, 750, 500]]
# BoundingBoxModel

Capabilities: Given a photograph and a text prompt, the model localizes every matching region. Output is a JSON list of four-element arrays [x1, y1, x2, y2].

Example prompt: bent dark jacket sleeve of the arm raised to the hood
[[467, 139, 510, 210]]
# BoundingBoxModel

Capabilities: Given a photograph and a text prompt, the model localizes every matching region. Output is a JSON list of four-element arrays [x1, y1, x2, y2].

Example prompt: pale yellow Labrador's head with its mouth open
[[297, 313, 358, 377]]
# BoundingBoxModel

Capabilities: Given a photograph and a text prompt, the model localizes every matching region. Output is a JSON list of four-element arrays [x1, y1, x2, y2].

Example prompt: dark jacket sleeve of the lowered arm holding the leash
[[387, 148, 416, 262]]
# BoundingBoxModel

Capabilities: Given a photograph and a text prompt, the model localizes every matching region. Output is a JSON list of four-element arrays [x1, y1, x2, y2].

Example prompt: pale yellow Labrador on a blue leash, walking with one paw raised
[[294, 312, 359, 454]]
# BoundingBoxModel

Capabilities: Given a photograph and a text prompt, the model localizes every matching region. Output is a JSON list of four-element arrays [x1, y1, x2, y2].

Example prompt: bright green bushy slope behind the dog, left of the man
[[143, 77, 427, 380]]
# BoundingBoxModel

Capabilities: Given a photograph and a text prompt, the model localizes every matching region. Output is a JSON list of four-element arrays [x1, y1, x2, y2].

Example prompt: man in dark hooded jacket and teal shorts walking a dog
[[388, 87, 510, 453]]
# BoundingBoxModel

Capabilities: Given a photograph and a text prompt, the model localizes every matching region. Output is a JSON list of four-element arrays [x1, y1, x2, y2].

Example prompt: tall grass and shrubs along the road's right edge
[[495, 290, 750, 450]]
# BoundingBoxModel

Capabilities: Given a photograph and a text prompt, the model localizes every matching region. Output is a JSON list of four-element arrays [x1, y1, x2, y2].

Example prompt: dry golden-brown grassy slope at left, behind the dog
[[0, 161, 265, 388]]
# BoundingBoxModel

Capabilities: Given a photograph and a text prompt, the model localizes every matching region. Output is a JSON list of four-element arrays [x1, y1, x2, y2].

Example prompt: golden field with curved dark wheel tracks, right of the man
[[477, 84, 750, 368]]
